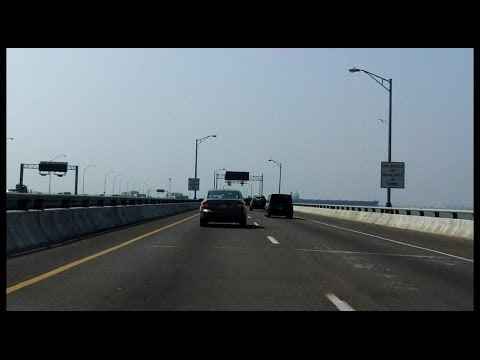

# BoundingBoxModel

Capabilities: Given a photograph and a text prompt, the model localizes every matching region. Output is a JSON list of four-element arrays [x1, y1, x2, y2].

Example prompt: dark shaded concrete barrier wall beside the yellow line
[[7, 202, 199, 255]]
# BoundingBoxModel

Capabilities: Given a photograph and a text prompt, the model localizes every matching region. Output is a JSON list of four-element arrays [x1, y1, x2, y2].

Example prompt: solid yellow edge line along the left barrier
[[7, 214, 198, 294]]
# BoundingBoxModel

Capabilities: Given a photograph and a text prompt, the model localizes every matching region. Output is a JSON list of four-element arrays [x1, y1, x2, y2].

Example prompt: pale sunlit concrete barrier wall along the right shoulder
[[293, 206, 473, 240]]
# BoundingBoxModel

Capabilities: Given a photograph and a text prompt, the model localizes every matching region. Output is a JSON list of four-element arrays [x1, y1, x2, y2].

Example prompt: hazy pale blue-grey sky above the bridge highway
[[6, 48, 473, 207]]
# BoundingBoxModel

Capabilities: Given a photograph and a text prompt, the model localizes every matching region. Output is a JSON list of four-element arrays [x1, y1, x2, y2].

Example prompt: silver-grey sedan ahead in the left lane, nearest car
[[200, 190, 247, 226]]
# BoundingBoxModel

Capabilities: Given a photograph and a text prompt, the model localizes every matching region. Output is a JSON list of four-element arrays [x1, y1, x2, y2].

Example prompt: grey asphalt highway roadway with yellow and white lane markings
[[6, 210, 474, 311]]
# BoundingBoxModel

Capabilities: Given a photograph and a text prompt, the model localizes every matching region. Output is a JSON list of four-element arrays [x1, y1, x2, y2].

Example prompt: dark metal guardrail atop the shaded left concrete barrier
[[7, 193, 199, 210]]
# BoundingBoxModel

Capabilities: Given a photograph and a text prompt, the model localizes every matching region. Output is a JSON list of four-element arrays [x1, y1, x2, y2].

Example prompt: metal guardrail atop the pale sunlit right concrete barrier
[[293, 203, 474, 220]]
